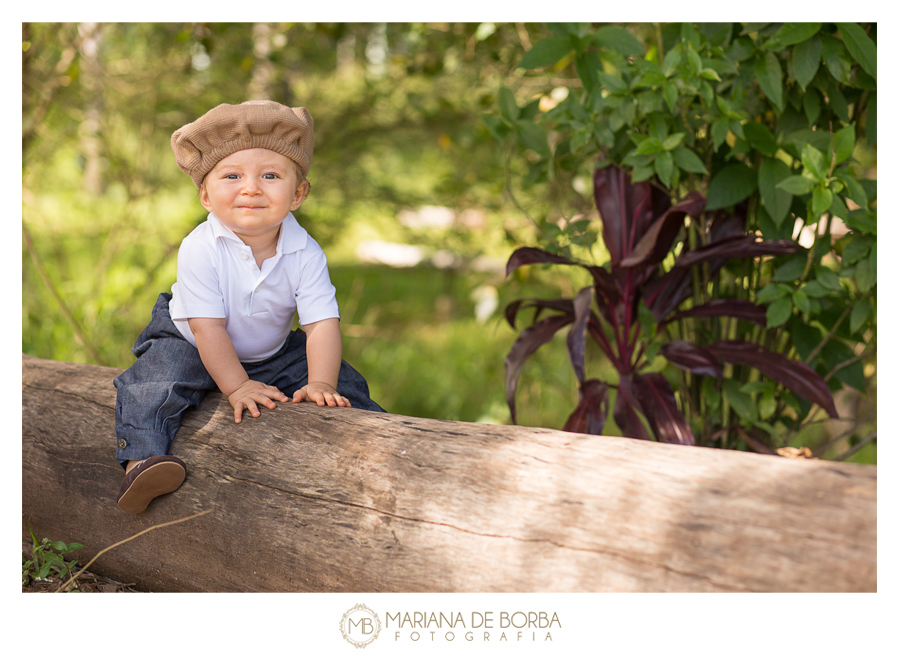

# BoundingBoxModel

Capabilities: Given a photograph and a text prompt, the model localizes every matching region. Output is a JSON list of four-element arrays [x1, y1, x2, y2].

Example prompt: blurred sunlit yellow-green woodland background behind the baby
[[22, 23, 875, 460]]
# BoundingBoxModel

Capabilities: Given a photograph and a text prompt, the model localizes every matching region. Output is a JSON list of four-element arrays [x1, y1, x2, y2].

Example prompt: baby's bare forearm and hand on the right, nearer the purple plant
[[293, 318, 352, 407]]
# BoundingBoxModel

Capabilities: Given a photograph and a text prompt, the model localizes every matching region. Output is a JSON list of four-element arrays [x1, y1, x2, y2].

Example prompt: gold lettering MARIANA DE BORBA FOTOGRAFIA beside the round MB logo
[[384, 612, 562, 642]]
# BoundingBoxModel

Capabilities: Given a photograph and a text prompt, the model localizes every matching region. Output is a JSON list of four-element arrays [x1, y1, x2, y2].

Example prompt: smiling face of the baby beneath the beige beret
[[200, 148, 309, 239]]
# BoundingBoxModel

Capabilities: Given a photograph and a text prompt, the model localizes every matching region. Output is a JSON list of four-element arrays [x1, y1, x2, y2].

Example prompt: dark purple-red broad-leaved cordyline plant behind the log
[[506, 165, 837, 445]]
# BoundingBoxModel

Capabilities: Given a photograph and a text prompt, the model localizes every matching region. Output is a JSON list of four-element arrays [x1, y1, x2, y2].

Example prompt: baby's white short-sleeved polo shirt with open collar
[[169, 213, 340, 362]]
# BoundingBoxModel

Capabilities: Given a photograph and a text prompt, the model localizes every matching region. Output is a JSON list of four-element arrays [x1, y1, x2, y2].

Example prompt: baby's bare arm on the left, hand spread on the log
[[188, 318, 288, 423]]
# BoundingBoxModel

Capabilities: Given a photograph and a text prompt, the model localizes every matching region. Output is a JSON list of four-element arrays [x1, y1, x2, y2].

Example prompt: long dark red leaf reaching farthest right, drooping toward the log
[[706, 340, 838, 418]]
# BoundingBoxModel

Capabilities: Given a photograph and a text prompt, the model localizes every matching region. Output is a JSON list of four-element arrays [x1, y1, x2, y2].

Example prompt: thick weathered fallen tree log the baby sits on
[[22, 356, 877, 592]]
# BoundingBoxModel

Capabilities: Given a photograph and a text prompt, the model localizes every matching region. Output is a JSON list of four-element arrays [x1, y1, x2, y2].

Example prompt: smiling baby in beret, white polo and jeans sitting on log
[[115, 101, 383, 513]]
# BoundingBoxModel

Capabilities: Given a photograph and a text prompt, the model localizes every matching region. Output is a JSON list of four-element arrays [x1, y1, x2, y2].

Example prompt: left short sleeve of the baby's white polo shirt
[[170, 236, 226, 320]]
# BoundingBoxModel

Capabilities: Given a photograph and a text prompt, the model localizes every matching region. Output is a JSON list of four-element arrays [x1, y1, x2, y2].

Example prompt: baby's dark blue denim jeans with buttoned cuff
[[113, 293, 384, 468]]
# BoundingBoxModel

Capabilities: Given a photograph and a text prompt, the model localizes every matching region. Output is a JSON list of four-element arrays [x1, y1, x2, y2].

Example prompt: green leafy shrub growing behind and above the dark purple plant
[[485, 23, 877, 451]]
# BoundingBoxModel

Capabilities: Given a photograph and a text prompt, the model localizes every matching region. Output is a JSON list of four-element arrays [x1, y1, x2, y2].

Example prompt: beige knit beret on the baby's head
[[172, 101, 313, 189]]
